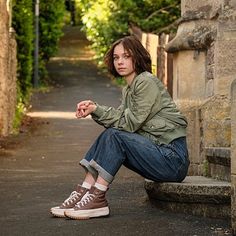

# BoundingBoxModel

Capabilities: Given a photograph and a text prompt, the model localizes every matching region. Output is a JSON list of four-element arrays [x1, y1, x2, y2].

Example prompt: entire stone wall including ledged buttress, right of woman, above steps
[[166, 0, 236, 175]]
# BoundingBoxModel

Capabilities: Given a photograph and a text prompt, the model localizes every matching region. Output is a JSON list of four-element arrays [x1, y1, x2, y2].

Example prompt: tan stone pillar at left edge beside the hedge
[[0, 1, 17, 136]]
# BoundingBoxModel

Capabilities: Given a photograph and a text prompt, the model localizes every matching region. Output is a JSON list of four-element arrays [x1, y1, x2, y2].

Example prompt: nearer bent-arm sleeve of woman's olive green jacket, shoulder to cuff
[[92, 79, 160, 132]]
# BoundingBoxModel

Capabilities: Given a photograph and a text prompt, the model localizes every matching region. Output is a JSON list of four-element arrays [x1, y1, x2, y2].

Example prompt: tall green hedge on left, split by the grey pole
[[12, 0, 65, 131]]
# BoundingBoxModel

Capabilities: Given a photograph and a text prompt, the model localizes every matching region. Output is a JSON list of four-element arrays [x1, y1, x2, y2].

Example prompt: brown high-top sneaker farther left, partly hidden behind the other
[[50, 185, 89, 217]]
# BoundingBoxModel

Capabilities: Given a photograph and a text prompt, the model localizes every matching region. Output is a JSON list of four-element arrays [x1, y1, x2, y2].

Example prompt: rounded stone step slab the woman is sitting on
[[145, 176, 231, 204]]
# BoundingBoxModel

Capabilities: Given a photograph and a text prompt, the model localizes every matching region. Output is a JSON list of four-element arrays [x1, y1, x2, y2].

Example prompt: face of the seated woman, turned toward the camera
[[113, 43, 136, 79]]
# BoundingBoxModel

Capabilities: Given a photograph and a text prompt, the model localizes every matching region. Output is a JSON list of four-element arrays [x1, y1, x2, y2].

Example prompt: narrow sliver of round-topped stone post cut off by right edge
[[231, 80, 236, 235]]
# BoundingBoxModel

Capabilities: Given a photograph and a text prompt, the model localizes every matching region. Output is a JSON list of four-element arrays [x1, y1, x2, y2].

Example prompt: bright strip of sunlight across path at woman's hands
[[27, 111, 92, 120]]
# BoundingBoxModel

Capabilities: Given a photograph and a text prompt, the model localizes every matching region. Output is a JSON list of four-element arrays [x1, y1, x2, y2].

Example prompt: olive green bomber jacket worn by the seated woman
[[91, 72, 187, 144]]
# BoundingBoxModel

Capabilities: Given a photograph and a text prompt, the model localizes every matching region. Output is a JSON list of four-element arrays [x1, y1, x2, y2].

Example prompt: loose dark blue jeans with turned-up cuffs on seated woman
[[80, 128, 189, 183]]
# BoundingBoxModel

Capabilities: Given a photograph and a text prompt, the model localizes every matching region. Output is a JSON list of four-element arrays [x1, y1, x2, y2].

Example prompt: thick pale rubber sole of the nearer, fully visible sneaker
[[64, 207, 110, 220]]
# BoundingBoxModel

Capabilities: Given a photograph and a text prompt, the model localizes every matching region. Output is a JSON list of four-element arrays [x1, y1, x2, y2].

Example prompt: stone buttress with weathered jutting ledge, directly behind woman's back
[[166, 0, 220, 175]]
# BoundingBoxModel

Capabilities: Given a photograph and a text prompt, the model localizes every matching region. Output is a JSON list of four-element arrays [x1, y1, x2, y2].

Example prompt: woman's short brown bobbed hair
[[104, 35, 152, 77]]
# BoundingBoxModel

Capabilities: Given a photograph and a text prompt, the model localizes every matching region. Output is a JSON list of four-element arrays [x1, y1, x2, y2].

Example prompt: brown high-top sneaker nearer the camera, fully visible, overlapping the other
[[65, 186, 109, 220]]
